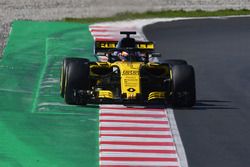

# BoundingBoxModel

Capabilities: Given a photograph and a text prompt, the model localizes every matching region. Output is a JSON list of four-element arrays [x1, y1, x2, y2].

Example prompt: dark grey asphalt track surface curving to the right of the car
[[144, 17, 250, 167]]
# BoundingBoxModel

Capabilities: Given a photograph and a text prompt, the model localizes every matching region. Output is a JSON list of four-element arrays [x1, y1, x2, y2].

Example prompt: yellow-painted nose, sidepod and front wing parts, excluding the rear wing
[[90, 61, 169, 101]]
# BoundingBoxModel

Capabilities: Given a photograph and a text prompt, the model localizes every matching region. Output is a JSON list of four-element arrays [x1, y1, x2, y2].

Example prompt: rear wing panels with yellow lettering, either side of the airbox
[[94, 41, 155, 54]]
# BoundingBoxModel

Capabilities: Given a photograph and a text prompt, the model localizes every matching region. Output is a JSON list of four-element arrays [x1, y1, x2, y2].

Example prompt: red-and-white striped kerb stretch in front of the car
[[99, 105, 180, 167]]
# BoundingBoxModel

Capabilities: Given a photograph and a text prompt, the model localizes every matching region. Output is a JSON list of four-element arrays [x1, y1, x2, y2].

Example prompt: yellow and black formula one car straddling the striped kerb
[[60, 32, 196, 107]]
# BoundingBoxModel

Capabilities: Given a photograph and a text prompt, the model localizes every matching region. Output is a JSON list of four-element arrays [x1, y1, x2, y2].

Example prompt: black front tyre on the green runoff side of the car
[[64, 59, 90, 105]]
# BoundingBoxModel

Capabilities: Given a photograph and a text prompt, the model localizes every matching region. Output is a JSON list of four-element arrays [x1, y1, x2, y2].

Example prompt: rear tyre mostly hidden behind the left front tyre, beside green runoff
[[60, 57, 88, 97]]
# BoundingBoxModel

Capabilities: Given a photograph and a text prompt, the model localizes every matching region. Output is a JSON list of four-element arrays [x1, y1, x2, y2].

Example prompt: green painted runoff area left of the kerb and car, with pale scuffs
[[0, 21, 99, 167]]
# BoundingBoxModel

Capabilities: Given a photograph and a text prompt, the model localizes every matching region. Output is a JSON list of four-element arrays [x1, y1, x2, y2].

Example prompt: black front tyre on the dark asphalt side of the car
[[172, 65, 196, 107]]
